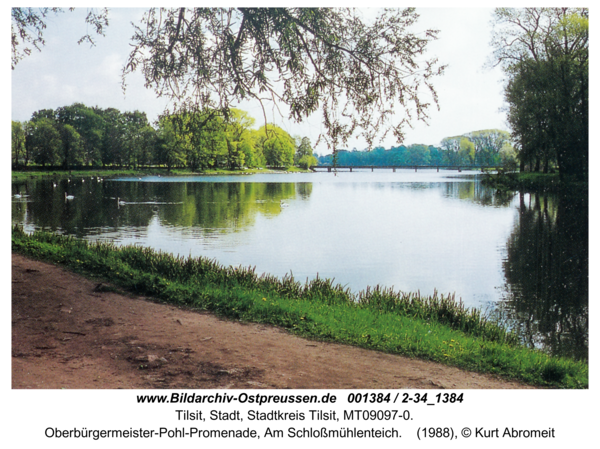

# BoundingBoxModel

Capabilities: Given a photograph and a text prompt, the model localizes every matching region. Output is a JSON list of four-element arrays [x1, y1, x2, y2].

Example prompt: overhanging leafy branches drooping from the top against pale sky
[[124, 8, 444, 150]]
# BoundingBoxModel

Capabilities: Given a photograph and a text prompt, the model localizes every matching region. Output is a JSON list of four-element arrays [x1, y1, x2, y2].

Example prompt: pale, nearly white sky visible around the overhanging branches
[[11, 2, 520, 154]]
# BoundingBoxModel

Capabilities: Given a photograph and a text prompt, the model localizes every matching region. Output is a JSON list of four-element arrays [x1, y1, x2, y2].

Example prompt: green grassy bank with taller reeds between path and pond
[[12, 228, 588, 388]]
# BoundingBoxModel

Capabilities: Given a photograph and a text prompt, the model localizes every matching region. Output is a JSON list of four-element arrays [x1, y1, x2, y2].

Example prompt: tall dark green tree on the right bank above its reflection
[[492, 8, 589, 179]]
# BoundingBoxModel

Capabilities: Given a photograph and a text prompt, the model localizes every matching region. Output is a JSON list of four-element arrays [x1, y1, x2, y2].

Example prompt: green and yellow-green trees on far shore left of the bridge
[[12, 103, 317, 170]]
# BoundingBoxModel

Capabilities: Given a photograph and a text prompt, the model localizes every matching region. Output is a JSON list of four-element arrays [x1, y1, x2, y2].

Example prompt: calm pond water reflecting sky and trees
[[12, 170, 588, 358]]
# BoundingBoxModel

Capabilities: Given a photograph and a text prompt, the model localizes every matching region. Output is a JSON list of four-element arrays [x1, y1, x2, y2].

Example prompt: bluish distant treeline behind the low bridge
[[318, 129, 517, 166]]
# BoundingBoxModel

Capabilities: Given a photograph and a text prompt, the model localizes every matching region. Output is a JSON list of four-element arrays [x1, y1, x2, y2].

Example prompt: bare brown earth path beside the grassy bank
[[12, 254, 528, 389]]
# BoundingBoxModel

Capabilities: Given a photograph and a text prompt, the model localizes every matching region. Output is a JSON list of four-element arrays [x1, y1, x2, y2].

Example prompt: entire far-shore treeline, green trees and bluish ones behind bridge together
[[12, 103, 517, 170]]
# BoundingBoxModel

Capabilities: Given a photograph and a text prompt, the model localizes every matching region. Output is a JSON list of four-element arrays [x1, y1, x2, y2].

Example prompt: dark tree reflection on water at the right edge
[[499, 194, 588, 359]]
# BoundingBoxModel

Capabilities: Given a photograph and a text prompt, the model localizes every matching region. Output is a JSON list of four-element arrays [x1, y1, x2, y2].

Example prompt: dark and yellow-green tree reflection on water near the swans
[[12, 178, 304, 237]]
